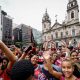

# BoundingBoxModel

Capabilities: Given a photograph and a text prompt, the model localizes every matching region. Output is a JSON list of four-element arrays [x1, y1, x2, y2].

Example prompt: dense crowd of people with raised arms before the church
[[0, 40, 80, 80]]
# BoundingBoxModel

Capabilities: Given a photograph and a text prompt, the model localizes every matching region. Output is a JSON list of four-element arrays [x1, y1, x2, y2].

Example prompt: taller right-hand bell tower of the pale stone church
[[67, 0, 79, 24]]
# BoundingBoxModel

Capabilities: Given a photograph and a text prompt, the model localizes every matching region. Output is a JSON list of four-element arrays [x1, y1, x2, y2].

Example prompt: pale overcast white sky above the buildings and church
[[0, 0, 80, 31]]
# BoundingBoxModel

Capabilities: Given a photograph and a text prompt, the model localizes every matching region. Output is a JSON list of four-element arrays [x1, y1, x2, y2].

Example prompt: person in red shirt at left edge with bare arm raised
[[0, 40, 16, 80]]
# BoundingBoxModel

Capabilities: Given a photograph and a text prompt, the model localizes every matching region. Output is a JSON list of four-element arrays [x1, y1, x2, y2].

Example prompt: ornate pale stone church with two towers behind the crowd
[[42, 0, 80, 47]]
